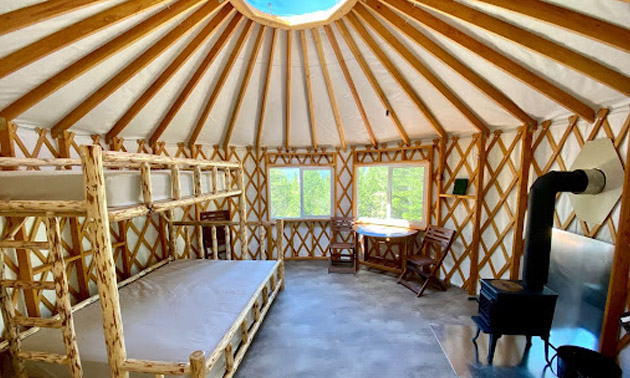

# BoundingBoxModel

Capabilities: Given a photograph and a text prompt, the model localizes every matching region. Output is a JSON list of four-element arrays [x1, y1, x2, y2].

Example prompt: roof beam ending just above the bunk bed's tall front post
[[107, 5, 233, 140]]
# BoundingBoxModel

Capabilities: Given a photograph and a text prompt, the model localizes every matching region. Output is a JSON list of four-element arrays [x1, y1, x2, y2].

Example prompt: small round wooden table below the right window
[[355, 224, 418, 273]]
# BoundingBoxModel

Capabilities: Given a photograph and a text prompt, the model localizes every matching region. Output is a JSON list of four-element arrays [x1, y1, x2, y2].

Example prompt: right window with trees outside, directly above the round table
[[354, 162, 429, 227]]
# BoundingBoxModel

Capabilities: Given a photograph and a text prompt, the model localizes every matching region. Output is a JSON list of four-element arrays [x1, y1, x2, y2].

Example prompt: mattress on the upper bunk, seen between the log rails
[[0, 170, 225, 207]]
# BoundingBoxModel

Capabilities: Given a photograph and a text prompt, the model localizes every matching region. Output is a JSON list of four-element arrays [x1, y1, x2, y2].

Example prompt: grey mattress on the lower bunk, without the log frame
[[22, 260, 276, 378]]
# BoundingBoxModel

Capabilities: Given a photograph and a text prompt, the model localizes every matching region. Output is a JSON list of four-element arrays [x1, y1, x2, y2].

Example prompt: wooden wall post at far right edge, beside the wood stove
[[599, 128, 630, 357]]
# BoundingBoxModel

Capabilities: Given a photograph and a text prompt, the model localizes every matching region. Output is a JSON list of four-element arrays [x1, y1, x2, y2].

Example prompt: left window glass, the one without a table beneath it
[[269, 167, 333, 218]]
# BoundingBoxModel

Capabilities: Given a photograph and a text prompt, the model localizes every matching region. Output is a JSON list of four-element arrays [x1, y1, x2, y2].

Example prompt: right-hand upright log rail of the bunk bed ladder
[[46, 217, 82, 378]]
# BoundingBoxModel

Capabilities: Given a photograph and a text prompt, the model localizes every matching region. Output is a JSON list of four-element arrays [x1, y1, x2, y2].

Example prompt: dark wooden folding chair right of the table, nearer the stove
[[398, 226, 455, 297]]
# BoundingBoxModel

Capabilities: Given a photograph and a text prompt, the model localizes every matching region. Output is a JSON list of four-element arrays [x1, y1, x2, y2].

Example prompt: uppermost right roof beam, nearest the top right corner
[[478, 0, 630, 52]]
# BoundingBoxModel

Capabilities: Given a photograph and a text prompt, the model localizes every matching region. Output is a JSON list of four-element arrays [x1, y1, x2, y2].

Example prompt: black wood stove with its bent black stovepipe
[[472, 170, 605, 364]]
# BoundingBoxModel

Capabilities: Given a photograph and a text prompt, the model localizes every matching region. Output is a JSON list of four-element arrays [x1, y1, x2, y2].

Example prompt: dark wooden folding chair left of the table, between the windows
[[328, 217, 358, 273]]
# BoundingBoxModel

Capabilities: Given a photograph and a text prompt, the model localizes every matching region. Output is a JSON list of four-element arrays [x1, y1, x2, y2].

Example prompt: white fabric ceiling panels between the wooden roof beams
[[0, 0, 630, 147]]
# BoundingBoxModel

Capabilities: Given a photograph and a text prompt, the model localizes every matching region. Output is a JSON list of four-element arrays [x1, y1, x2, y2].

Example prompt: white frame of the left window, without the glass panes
[[267, 164, 337, 220]]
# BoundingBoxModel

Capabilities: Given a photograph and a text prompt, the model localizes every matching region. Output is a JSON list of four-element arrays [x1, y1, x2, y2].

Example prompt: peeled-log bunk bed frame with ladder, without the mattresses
[[0, 145, 284, 378]]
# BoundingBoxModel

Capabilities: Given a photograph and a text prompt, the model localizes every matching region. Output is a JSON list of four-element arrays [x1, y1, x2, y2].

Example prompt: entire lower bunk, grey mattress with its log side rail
[[22, 260, 284, 378]]
